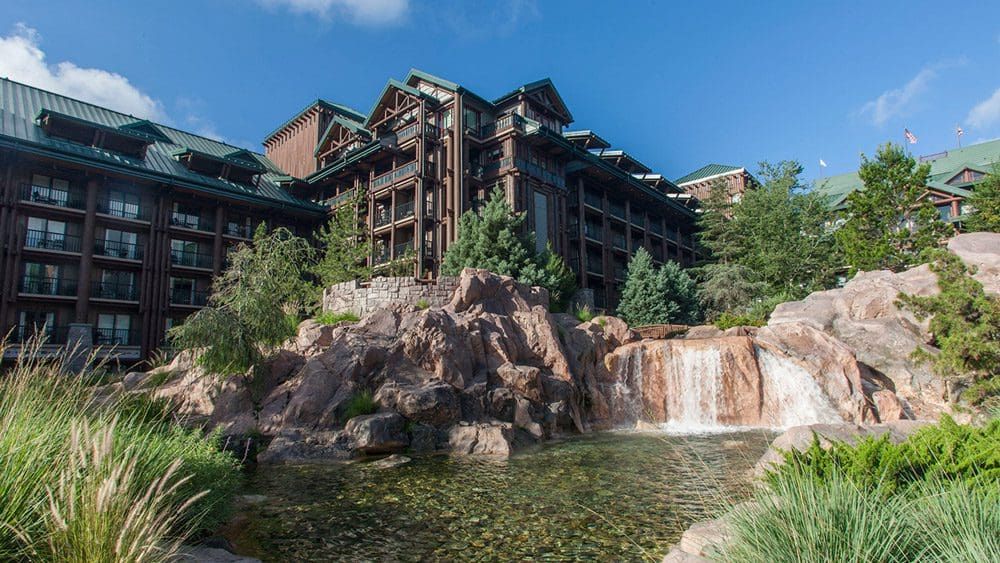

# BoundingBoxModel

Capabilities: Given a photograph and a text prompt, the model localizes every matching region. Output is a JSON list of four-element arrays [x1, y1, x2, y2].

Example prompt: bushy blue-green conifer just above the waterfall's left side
[[618, 248, 699, 326]]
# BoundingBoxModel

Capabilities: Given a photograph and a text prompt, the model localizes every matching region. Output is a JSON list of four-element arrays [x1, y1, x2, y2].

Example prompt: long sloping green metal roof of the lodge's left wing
[[0, 78, 322, 212]]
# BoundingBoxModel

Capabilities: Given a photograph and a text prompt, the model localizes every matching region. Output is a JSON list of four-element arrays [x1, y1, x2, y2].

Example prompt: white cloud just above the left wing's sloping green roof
[[0, 23, 166, 121]]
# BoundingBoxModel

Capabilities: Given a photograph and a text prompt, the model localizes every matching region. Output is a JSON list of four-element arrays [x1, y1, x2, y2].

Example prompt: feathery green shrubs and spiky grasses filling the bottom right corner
[[721, 416, 1000, 563]]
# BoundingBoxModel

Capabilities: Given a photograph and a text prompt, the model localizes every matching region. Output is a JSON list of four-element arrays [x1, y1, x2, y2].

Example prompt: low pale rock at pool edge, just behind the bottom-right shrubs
[[754, 420, 930, 476]]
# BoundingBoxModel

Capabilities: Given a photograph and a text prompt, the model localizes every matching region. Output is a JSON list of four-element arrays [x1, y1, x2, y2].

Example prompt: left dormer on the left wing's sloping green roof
[[35, 109, 156, 159]]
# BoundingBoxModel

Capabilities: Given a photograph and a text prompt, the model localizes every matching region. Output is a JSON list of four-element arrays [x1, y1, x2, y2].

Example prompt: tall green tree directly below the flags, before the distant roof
[[836, 143, 948, 272]]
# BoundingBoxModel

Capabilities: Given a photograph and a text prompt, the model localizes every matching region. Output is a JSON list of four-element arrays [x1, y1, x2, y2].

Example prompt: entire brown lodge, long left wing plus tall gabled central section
[[0, 70, 697, 361]]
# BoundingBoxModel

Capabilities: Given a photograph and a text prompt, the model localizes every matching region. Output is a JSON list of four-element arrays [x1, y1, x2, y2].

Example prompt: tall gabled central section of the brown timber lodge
[[264, 70, 696, 309]]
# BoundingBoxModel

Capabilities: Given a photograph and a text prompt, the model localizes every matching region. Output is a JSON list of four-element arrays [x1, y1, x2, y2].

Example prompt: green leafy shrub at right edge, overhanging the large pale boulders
[[899, 250, 1000, 403]]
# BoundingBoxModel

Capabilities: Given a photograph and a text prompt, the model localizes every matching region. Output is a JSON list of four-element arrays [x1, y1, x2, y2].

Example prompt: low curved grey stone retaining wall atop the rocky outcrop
[[323, 277, 458, 317]]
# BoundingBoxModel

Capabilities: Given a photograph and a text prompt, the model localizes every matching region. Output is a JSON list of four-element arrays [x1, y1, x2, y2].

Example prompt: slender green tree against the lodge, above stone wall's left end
[[312, 193, 372, 287]]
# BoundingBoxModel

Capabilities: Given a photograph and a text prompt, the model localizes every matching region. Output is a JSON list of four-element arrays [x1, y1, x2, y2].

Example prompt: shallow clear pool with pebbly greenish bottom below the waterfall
[[231, 432, 773, 561]]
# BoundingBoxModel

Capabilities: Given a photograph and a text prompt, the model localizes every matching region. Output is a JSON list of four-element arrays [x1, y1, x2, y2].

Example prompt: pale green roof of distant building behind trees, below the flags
[[815, 140, 1000, 209]]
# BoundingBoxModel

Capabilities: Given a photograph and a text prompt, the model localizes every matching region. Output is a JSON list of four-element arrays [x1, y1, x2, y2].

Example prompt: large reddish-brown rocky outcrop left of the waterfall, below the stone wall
[[144, 270, 636, 463]]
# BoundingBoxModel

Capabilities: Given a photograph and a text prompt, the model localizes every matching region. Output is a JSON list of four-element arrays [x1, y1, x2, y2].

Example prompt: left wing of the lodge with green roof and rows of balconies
[[0, 79, 324, 360]]
